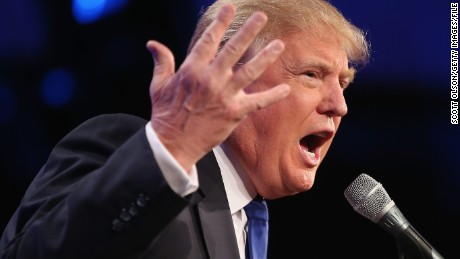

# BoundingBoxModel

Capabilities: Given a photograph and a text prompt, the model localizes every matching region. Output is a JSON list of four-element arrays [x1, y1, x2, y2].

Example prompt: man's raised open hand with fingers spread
[[147, 5, 290, 171]]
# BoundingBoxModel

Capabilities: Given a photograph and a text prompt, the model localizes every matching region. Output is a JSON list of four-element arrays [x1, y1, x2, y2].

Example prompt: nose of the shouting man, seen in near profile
[[318, 82, 348, 117]]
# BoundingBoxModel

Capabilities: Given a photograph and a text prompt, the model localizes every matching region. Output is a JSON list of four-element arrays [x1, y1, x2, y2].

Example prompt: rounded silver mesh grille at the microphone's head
[[344, 174, 392, 222]]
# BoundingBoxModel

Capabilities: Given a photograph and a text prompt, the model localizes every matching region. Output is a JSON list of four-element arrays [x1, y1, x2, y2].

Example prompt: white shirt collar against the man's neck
[[213, 146, 257, 214]]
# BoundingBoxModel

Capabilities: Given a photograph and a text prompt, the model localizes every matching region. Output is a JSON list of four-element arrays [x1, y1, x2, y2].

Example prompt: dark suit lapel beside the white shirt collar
[[197, 152, 239, 259]]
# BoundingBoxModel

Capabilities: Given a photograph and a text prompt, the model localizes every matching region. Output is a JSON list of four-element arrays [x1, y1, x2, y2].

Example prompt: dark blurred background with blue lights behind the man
[[0, 0, 460, 258]]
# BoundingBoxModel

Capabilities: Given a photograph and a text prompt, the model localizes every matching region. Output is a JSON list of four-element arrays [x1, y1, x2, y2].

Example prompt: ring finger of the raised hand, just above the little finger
[[230, 40, 284, 91]]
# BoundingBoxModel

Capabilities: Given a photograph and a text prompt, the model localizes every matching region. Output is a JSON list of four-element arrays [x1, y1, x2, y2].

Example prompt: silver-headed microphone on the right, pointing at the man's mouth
[[344, 174, 444, 259]]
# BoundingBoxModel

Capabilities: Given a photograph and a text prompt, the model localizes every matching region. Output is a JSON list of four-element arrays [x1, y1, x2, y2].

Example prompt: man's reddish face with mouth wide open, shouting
[[224, 32, 354, 199]]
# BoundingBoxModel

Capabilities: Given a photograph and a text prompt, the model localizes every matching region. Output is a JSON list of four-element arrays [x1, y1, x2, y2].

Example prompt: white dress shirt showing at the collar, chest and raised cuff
[[145, 122, 257, 259]]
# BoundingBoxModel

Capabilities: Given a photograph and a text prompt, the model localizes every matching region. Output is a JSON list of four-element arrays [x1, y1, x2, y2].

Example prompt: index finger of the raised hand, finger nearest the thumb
[[189, 4, 235, 64]]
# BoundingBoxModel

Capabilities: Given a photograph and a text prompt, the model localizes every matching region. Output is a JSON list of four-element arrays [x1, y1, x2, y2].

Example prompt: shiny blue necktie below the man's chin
[[244, 196, 268, 259]]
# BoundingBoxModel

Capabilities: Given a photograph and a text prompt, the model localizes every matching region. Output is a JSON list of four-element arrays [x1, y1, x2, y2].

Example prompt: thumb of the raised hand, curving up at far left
[[147, 40, 175, 87]]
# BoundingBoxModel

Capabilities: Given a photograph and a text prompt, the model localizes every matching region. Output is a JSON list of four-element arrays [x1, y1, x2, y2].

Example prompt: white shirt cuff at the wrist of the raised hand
[[145, 122, 199, 197]]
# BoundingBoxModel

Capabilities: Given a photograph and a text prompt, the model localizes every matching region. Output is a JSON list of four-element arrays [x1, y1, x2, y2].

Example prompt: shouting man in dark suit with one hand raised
[[0, 0, 368, 259]]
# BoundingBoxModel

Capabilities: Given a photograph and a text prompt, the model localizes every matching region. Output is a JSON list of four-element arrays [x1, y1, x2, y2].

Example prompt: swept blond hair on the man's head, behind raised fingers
[[189, 0, 369, 66]]
